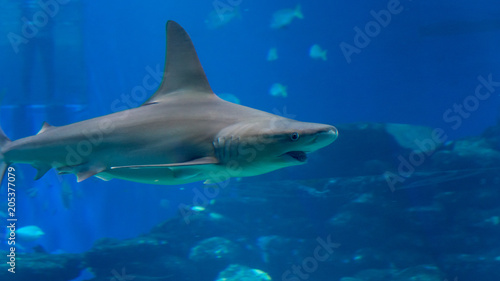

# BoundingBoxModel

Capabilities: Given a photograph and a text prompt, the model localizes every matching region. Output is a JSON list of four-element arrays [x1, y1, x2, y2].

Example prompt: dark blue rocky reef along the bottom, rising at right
[[0, 121, 500, 281]]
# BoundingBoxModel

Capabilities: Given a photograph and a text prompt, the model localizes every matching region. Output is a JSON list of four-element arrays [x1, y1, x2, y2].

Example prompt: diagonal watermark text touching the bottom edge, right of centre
[[281, 235, 340, 281]]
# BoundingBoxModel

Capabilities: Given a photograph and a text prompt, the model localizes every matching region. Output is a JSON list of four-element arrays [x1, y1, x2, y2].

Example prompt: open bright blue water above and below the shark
[[0, 0, 500, 278]]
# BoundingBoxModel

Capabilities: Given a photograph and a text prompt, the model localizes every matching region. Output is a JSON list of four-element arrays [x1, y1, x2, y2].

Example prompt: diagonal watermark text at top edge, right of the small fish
[[339, 0, 411, 63]]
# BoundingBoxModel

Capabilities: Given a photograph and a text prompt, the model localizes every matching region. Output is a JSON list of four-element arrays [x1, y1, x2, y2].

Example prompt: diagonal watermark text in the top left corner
[[7, 0, 71, 54]]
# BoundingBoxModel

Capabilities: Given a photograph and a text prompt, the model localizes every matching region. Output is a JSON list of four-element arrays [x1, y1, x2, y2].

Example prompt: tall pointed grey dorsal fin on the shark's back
[[144, 21, 214, 105]]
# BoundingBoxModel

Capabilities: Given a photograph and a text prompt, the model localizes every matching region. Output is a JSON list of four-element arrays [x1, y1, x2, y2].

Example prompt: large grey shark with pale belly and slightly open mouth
[[0, 21, 338, 185]]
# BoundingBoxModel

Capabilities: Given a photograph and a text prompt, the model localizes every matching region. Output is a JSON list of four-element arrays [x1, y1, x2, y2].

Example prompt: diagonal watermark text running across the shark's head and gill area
[[178, 107, 296, 224]]
